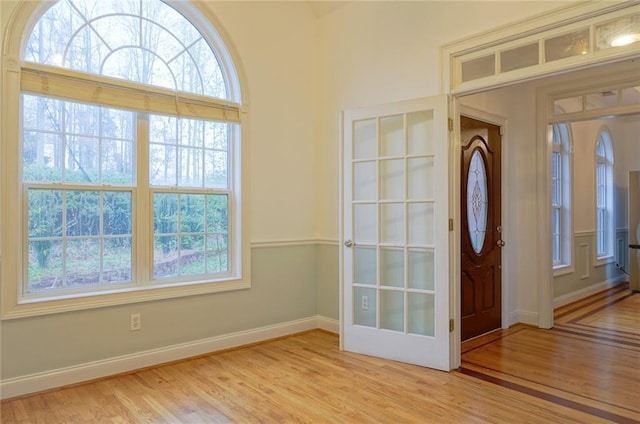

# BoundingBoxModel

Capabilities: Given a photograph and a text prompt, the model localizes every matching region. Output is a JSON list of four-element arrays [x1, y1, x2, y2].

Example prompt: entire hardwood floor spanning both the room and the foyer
[[0, 289, 640, 424]]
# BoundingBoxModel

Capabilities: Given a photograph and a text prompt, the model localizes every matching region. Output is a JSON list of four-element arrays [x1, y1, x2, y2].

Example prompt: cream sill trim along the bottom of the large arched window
[[2, 279, 251, 320]]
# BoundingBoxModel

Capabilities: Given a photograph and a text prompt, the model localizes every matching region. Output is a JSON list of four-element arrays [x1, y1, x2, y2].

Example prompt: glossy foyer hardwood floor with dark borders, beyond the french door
[[460, 284, 640, 423]]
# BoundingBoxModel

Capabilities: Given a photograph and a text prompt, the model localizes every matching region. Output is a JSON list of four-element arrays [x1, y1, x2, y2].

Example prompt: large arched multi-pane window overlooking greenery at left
[[3, 0, 246, 314]]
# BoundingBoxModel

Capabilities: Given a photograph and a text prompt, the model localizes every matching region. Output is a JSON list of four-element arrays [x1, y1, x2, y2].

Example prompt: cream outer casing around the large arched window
[[0, 1, 251, 319]]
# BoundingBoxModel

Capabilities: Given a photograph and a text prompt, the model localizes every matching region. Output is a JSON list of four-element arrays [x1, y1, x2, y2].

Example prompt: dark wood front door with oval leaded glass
[[460, 116, 504, 340]]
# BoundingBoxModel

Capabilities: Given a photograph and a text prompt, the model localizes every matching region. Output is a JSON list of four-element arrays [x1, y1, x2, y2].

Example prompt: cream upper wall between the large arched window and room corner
[[205, 1, 318, 241]]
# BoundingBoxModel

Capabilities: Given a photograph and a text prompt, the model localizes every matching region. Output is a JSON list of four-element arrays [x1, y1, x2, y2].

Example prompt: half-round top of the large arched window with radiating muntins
[[23, 0, 233, 99]]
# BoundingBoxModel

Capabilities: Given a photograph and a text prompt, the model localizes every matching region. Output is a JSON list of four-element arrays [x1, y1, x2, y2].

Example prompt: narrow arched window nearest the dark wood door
[[551, 123, 573, 270]]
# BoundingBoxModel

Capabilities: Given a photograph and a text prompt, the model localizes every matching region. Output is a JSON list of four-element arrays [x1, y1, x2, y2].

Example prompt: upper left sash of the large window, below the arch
[[22, 94, 135, 185]]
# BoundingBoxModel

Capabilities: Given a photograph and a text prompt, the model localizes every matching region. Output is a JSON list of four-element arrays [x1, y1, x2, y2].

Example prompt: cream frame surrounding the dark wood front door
[[458, 104, 514, 341]]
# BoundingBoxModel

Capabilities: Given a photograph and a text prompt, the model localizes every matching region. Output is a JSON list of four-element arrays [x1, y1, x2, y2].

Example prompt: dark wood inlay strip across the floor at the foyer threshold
[[459, 367, 638, 424]]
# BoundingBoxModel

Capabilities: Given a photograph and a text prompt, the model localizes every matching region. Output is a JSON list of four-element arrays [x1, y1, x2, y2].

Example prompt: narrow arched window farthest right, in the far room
[[595, 129, 614, 260]]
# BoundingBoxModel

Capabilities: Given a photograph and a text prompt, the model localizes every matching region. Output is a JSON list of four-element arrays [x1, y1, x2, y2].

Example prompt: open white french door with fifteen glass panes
[[341, 95, 451, 370]]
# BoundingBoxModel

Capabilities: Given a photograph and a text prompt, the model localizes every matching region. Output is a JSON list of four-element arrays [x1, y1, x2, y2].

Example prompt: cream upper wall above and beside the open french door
[[317, 1, 570, 239]]
